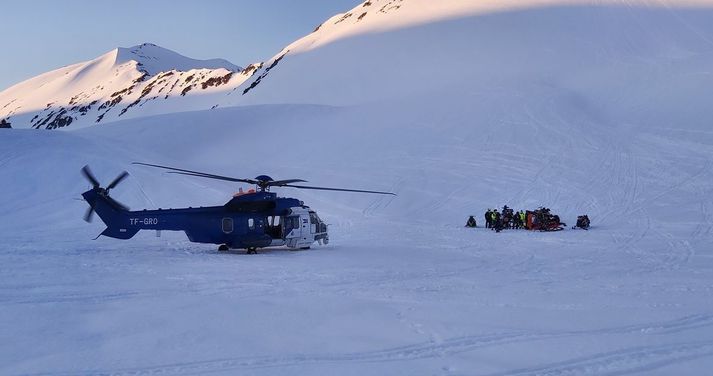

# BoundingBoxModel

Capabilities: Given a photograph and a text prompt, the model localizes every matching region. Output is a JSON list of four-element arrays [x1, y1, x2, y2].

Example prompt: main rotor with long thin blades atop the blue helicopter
[[132, 162, 396, 196]]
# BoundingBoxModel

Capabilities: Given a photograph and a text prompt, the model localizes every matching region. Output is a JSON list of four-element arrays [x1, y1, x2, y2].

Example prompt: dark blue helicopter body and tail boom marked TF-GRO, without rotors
[[82, 189, 329, 250]]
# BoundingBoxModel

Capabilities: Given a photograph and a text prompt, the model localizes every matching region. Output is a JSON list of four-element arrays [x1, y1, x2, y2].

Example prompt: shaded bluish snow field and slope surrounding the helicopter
[[0, 1, 713, 375]]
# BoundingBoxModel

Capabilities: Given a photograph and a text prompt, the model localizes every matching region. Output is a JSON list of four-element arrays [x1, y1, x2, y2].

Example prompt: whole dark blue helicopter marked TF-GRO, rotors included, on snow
[[81, 162, 395, 254]]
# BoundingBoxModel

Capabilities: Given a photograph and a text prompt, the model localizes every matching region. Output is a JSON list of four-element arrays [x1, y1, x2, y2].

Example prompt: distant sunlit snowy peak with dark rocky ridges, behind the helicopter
[[0, 43, 254, 129]]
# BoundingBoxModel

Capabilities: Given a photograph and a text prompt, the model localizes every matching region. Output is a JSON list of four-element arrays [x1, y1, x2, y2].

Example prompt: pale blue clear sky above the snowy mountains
[[0, 0, 361, 91]]
